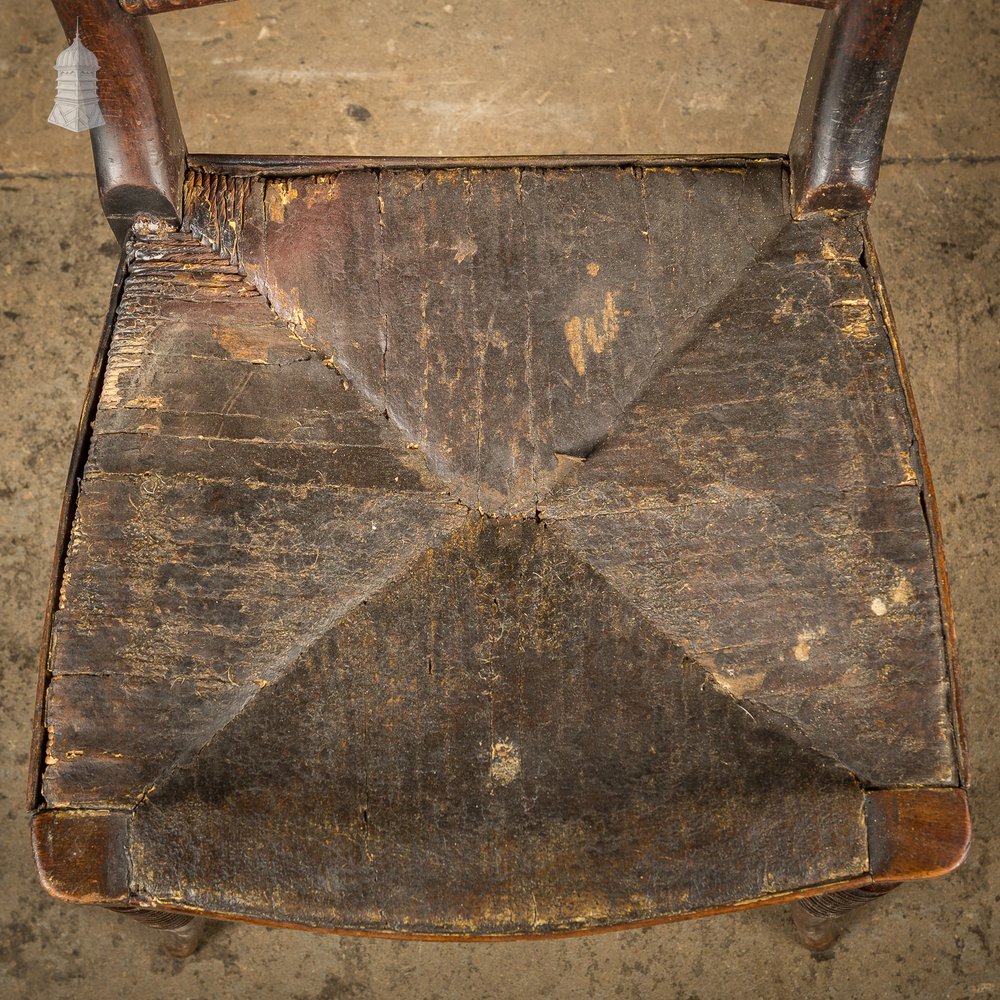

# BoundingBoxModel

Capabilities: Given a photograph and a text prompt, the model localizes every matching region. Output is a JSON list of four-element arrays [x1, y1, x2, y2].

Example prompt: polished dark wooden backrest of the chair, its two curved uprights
[[52, 0, 921, 240]]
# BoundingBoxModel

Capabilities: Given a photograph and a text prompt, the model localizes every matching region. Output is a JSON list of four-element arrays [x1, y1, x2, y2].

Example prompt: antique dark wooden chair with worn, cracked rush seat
[[31, 0, 969, 951]]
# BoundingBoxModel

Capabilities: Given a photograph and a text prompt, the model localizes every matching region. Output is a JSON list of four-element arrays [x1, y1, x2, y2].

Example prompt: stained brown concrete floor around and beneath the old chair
[[0, 0, 1000, 1000]]
